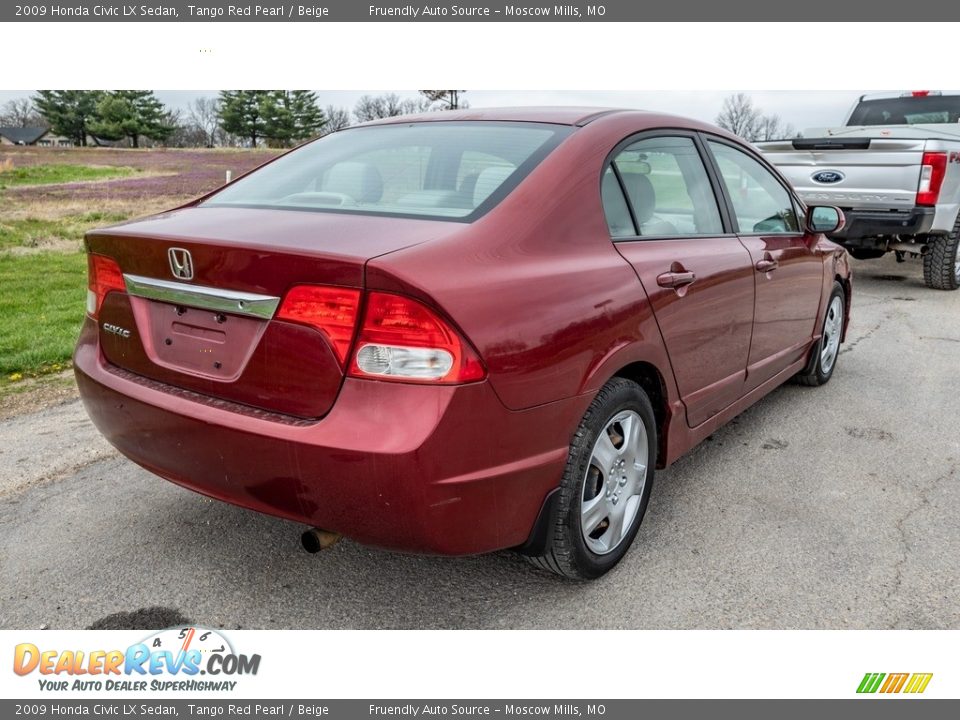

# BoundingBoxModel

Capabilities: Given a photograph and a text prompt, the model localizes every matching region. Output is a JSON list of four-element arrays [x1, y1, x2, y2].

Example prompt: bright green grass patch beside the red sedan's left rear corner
[[0, 252, 87, 386]]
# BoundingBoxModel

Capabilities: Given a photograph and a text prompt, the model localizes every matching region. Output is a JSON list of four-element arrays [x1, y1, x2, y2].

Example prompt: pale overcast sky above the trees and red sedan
[[0, 89, 872, 130]]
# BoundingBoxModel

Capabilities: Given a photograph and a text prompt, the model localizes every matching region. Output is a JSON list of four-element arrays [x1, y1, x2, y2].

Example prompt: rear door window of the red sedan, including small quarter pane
[[601, 137, 723, 237]]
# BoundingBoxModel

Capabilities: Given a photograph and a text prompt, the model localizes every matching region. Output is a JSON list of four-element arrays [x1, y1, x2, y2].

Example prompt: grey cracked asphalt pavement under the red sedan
[[0, 258, 960, 629]]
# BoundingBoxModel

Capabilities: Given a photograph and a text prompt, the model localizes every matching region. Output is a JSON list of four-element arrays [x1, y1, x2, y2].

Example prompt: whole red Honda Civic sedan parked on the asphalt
[[75, 108, 850, 578]]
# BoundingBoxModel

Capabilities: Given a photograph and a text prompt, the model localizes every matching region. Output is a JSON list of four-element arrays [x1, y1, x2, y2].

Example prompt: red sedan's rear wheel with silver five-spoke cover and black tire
[[527, 378, 657, 580]]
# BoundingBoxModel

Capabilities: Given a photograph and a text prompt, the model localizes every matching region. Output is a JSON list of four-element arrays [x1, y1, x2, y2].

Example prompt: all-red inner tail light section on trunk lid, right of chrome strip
[[277, 285, 360, 368]]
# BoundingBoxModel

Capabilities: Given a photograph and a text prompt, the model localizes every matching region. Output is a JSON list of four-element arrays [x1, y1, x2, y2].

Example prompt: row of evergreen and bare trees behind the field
[[0, 90, 466, 148]]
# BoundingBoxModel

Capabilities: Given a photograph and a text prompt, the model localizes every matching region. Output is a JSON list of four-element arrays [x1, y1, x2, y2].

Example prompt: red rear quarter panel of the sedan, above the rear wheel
[[367, 115, 676, 410]]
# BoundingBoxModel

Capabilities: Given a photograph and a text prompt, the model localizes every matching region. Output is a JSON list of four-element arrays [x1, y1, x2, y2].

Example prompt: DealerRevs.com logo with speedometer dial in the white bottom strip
[[13, 627, 260, 692]]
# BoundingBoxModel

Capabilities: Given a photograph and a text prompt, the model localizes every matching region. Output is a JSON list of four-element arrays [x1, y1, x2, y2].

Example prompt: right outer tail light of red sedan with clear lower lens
[[349, 292, 486, 384]]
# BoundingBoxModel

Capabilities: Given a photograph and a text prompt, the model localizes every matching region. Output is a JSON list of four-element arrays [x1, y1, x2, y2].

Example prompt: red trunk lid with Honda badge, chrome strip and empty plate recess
[[86, 208, 462, 418]]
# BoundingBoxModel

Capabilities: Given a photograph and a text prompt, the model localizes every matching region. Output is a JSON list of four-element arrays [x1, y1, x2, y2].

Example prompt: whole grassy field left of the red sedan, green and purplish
[[0, 147, 275, 394]]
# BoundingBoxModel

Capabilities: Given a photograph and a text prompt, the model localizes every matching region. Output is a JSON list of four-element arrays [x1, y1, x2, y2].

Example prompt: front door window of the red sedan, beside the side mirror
[[709, 140, 800, 235]]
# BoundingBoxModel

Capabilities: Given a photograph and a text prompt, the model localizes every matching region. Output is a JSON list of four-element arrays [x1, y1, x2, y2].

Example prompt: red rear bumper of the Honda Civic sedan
[[74, 319, 590, 555]]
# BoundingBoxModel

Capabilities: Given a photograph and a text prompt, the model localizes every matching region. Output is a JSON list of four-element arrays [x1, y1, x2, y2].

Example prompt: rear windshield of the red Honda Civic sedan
[[203, 121, 571, 221]]
